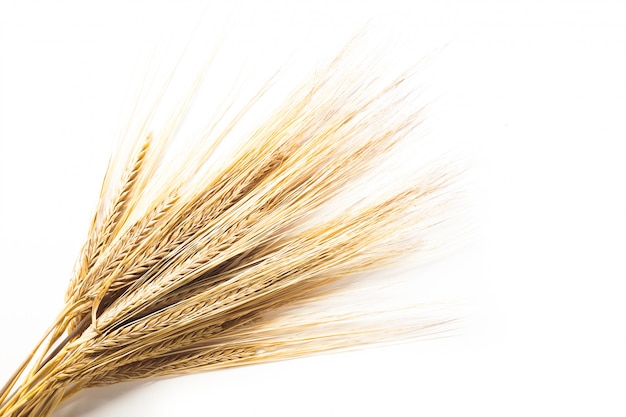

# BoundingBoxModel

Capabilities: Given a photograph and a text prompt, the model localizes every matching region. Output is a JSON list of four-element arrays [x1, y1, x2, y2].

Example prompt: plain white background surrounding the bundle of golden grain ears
[[0, 1, 626, 417]]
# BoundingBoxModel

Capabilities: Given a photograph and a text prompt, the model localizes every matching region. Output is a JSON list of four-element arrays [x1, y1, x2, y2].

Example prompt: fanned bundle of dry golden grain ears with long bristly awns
[[0, 40, 455, 417]]
